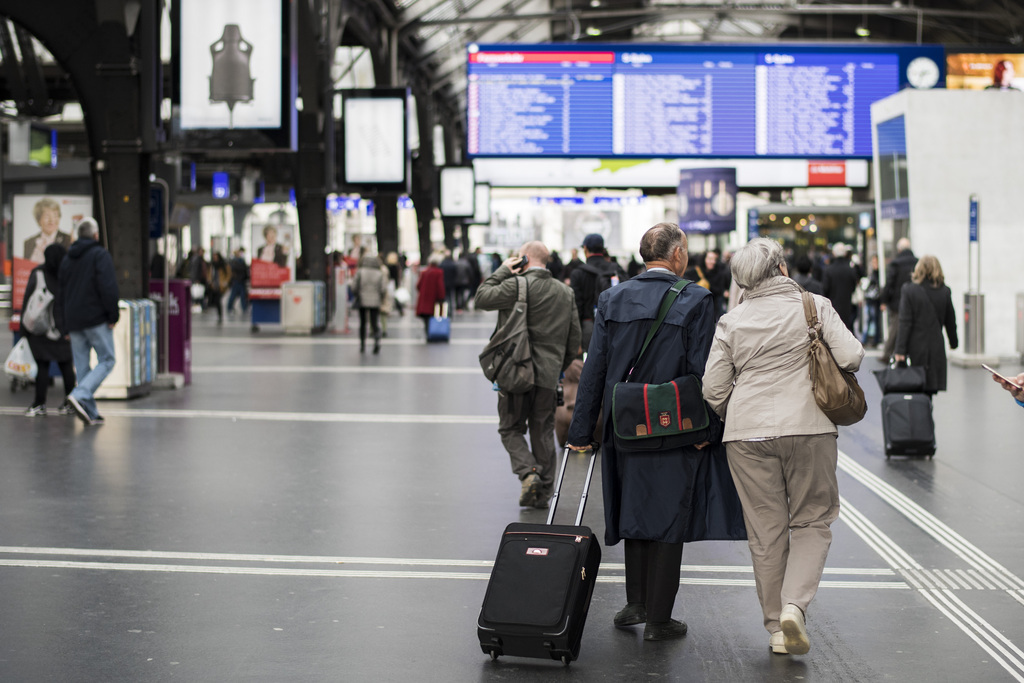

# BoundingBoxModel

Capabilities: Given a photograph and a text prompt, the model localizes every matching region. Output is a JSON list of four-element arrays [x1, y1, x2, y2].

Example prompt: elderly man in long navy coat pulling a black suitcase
[[568, 223, 744, 640]]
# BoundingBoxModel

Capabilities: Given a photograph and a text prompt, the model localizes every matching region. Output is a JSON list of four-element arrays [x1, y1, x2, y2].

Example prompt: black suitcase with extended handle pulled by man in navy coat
[[476, 449, 601, 666]]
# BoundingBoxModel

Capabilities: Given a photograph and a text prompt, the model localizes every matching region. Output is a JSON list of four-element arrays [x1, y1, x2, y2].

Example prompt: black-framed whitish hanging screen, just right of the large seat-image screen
[[338, 88, 410, 193]]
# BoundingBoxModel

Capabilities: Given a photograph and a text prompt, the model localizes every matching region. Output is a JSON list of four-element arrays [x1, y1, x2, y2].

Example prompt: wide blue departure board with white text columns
[[466, 44, 943, 159]]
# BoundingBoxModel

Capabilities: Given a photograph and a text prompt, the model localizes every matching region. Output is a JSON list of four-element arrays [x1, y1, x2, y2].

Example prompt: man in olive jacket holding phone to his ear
[[473, 242, 580, 508]]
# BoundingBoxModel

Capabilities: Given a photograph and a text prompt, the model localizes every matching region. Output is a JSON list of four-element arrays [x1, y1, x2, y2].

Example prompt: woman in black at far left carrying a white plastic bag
[[22, 244, 75, 418]]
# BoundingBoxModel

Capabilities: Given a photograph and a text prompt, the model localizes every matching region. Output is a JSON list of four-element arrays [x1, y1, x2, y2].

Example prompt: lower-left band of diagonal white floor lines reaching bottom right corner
[[840, 499, 1024, 683]]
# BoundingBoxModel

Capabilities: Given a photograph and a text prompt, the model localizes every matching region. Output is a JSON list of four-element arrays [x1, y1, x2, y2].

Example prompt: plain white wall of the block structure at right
[[871, 89, 1024, 357]]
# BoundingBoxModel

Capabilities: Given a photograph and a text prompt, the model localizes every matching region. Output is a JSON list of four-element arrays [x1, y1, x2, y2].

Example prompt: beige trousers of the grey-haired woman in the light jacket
[[725, 434, 839, 633]]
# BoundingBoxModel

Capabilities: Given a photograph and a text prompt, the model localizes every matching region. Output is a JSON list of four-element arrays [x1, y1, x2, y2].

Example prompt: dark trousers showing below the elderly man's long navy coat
[[626, 539, 683, 624]]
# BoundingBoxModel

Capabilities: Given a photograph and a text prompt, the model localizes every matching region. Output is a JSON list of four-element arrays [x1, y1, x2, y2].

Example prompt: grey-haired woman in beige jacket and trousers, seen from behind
[[703, 238, 864, 654]]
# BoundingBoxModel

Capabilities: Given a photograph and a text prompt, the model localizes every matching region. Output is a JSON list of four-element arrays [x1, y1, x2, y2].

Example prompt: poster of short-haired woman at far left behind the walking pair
[[11, 195, 92, 310]]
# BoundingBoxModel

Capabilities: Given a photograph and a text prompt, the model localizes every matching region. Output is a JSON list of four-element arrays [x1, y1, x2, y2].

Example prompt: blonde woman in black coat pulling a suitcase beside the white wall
[[893, 255, 959, 394]]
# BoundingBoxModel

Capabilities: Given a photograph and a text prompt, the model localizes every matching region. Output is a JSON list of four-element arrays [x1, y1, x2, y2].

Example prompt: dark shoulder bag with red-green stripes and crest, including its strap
[[611, 280, 712, 452]]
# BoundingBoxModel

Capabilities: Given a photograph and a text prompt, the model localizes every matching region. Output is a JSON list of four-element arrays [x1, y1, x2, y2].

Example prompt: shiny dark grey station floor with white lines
[[0, 305, 1024, 682]]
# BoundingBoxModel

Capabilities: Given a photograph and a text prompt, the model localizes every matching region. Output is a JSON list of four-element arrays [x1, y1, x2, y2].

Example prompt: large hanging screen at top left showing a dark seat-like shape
[[173, 0, 298, 150]]
